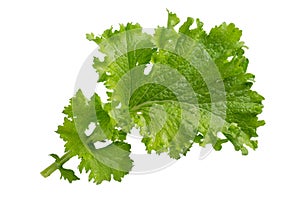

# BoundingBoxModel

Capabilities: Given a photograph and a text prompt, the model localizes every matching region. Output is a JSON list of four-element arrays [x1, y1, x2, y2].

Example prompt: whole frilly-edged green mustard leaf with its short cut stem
[[41, 10, 265, 184]]
